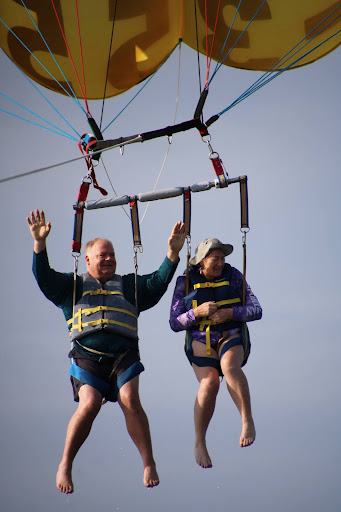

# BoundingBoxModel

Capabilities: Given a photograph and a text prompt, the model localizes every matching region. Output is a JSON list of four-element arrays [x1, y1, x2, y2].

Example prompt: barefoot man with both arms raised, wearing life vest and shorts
[[27, 210, 185, 493]]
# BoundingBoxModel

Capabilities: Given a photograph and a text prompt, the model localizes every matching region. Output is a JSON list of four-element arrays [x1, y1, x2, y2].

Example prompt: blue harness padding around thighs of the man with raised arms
[[69, 361, 144, 402]]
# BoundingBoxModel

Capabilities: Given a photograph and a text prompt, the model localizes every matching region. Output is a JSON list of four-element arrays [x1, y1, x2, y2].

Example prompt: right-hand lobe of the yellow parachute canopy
[[183, 0, 341, 71]]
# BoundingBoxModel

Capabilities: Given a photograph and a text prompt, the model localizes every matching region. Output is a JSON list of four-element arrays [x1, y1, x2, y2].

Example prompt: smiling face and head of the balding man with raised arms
[[85, 240, 116, 283]]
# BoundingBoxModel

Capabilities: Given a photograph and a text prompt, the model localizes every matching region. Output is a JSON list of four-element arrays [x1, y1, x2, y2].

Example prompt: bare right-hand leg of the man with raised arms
[[118, 375, 159, 487]]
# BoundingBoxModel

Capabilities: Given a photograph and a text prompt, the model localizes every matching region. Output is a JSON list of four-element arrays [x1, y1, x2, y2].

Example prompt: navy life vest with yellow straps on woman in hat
[[184, 263, 242, 355]]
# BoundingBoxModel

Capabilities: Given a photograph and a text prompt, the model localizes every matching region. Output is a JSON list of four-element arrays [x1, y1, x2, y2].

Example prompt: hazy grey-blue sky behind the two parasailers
[[0, 18, 341, 512]]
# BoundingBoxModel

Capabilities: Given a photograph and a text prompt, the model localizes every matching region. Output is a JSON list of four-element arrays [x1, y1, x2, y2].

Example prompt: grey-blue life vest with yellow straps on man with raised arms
[[68, 272, 138, 341]]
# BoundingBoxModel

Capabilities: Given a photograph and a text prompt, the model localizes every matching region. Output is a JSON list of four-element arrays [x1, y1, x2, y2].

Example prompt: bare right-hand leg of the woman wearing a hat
[[220, 344, 256, 446]]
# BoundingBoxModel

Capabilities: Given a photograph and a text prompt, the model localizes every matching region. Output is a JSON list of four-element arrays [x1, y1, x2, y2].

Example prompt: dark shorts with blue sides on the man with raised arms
[[69, 348, 144, 402]]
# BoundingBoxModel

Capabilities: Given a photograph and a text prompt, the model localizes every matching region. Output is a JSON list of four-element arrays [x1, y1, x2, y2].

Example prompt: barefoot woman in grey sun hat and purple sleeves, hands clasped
[[170, 238, 262, 468]]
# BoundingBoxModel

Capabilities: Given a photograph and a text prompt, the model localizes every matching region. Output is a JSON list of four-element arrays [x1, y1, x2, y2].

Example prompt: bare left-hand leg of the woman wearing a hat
[[192, 341, 219, 468]]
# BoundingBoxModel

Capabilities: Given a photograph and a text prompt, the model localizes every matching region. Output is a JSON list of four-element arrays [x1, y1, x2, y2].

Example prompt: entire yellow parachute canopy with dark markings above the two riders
[[0, 0, 341, 99]]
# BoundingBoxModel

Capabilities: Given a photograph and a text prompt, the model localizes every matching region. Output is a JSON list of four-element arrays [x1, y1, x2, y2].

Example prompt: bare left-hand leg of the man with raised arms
[[56, 384, 102, 494]]
